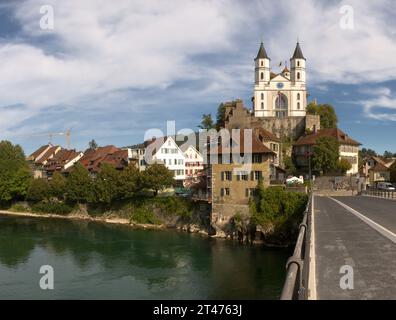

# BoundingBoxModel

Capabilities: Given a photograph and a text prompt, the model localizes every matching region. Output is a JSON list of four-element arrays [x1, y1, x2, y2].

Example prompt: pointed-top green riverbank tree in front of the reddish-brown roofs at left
[[66, 163, 93, 203]]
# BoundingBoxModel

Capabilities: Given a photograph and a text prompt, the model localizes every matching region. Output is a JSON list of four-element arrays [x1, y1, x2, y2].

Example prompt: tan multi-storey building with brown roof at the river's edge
[[192, 129, 276, 223]]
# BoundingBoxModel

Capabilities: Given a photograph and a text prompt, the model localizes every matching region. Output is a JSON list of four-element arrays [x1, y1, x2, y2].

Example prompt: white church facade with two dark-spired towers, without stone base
[[253, 42, 307, 118]]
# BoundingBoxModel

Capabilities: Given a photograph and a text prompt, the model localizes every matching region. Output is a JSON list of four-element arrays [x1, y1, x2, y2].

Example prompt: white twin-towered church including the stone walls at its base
[[224, 42, 320, 140]]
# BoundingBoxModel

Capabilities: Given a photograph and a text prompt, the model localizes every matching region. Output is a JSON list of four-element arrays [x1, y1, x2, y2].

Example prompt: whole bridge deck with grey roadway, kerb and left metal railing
[[281, 193, 396, 300]]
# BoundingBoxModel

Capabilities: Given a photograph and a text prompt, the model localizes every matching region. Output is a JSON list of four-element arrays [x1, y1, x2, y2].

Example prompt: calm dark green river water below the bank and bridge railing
[[0, 216, 291, 299]]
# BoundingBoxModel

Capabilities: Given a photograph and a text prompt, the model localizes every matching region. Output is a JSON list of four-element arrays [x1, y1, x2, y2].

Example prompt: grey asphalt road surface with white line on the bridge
[[314, 196, 396, 300]]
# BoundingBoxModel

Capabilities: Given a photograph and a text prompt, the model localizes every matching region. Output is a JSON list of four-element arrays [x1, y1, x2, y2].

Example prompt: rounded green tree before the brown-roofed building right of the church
[[312, 137, 340, 173]]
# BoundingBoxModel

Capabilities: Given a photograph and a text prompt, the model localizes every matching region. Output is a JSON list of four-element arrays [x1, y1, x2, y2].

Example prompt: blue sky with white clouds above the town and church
[[0, 0, 396, 154]]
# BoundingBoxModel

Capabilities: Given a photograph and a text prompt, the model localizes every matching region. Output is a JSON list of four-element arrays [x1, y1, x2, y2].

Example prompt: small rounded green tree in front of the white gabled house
[[142, 163, 174, 195]]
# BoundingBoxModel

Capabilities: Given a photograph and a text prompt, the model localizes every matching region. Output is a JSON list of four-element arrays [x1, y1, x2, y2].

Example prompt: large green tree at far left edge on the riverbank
[[0, 141, 31, 202]]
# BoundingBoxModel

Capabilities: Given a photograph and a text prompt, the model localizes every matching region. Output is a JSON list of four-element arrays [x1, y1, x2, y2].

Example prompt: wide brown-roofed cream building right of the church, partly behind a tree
[[293, 128, 360, 174]]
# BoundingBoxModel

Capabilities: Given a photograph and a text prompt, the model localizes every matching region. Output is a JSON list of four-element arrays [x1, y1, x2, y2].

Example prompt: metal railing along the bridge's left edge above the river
[[281, 193, 313, 300]]
